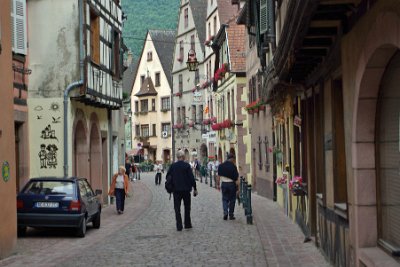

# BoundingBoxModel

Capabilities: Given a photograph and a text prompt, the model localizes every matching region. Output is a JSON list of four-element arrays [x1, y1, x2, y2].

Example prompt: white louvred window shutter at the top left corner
[[13, 0, 27, 55]]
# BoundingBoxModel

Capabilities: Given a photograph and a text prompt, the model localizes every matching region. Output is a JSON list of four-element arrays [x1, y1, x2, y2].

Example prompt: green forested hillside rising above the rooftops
[[121, 0, 180, 60]]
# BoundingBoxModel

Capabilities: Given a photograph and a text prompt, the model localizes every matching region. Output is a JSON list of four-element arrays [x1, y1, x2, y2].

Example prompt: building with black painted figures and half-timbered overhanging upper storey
[[28, 0, 123, 204]]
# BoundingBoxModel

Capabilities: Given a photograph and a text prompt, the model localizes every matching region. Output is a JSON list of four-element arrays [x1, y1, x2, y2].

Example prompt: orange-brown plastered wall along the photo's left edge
[[0, 1, 17, 259]]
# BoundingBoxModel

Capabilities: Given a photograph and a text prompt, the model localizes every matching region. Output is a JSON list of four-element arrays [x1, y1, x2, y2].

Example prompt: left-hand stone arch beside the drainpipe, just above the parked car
[[73, 120, 89, 178]]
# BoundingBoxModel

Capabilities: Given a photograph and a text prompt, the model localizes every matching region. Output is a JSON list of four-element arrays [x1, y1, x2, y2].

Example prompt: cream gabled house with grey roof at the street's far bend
[[131, 30, 176, 163]]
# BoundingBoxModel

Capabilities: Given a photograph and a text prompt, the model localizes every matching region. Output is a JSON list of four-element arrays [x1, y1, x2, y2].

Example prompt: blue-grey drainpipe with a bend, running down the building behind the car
[[64, 0, 84, 177]]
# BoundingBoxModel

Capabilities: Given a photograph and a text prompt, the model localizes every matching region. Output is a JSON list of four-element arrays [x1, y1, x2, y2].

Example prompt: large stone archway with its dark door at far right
[[352, 44, 400, 255]]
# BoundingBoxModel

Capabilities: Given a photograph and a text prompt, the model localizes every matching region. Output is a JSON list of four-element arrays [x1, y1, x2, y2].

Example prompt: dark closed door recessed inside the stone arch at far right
[[375, 50, 400, 251]]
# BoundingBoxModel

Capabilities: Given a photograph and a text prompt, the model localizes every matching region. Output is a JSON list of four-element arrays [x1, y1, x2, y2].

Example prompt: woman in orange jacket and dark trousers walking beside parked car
[[108, 166, 129, 214]]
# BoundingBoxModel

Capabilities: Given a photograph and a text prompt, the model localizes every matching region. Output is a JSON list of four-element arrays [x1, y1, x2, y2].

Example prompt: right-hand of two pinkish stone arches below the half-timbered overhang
[[89, 119, 103, 193]]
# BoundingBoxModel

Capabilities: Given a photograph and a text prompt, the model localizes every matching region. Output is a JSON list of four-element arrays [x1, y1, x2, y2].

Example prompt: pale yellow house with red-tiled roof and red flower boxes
[[211, 17, 250, 180]]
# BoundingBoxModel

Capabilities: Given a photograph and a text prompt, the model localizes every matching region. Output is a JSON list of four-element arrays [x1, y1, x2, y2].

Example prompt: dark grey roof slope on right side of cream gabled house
[[149, 30, 176, 87]]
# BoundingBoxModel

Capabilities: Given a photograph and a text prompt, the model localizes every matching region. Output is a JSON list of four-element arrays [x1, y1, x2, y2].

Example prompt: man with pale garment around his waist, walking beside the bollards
[[217, 153, 239, 220]]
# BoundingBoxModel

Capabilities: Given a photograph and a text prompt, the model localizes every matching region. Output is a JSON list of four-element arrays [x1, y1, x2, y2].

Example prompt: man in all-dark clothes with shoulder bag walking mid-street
[[167, 150, 197, 231]]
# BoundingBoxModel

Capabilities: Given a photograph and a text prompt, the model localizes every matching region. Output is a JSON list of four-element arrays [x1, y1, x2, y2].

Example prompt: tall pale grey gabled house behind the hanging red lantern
[[172, 0, 209, 162]]
